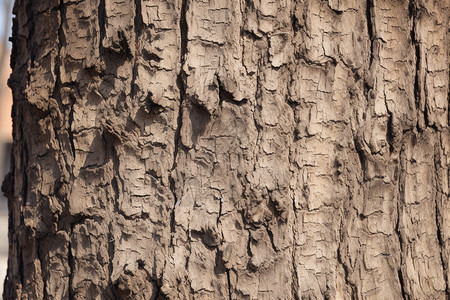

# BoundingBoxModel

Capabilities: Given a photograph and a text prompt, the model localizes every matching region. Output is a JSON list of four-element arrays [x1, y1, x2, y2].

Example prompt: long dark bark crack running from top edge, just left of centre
[[169, 0, 188, 233]]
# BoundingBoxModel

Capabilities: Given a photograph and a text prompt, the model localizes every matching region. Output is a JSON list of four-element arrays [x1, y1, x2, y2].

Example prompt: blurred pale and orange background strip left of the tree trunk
[[0, 0, 13, 299]]
